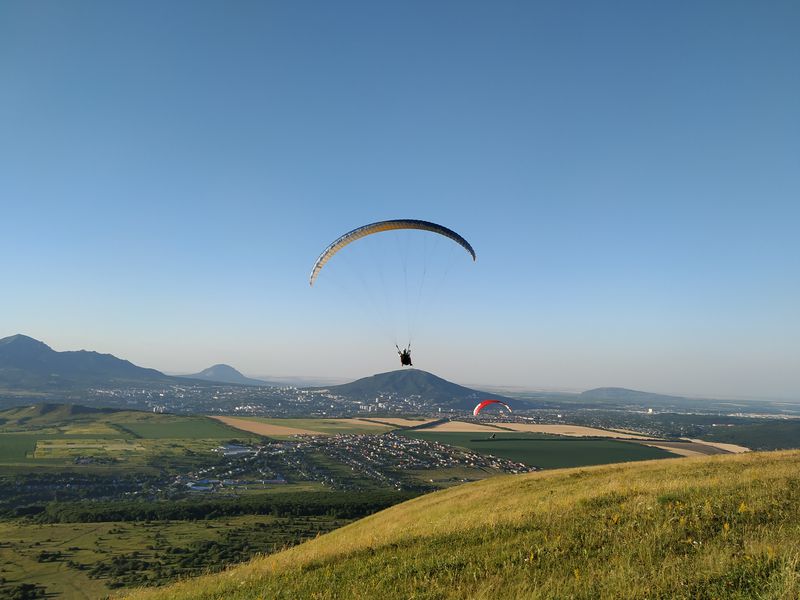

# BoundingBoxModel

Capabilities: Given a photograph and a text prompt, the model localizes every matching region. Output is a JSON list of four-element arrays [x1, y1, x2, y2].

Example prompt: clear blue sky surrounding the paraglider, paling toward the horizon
[[0, 0, 800, 398]]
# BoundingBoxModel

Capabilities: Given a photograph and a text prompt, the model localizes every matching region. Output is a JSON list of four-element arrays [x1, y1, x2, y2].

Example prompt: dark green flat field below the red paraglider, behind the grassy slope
[[402, 430, 675, 469]]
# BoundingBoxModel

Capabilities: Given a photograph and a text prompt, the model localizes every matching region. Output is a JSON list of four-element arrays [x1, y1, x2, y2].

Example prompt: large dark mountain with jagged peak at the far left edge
[[0, 334, 171, 390]]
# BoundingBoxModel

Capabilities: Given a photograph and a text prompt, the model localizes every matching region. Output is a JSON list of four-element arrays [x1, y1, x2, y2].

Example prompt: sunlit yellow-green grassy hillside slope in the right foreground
[[125, 451, 800, 599]]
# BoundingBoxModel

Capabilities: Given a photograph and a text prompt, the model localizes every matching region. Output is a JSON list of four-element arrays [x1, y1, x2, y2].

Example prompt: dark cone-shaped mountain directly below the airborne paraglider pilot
[[326, 369, 533, 409]]
